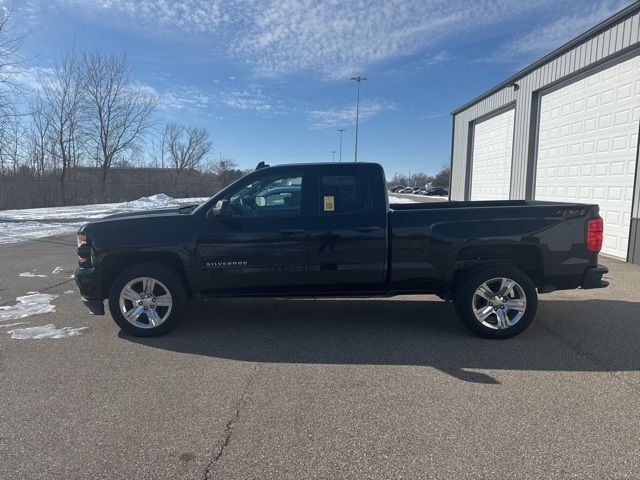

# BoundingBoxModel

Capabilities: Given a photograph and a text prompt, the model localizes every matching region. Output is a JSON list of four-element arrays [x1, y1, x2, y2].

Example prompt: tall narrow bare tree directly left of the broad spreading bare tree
[[41, 51, 83, 202]]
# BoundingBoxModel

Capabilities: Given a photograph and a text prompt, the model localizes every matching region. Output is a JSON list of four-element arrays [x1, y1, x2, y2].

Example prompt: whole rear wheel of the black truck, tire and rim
[[456, 266, 538, 338]]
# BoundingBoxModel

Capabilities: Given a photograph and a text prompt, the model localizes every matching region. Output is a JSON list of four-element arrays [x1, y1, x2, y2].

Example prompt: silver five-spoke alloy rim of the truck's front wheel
[[118, 277, 173, 328]]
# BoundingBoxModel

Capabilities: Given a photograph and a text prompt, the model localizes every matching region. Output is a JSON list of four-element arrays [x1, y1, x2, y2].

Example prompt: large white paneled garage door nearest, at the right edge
[[536, 57, 640, 259]]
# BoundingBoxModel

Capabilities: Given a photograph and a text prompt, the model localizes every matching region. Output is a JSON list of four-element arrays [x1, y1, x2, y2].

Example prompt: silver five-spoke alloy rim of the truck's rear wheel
[[471, 278, 527, 330]]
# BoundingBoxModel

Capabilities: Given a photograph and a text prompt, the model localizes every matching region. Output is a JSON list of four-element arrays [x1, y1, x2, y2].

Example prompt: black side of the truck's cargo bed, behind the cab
[[389, 200, 598, 290]]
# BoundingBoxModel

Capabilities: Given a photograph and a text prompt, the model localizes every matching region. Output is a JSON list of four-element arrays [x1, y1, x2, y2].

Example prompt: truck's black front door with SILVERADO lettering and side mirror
[[196, 168, 309, 294]]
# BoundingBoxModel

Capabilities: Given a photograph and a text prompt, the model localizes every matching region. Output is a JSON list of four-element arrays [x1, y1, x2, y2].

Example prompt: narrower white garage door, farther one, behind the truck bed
[[471, 109, 515, 200]]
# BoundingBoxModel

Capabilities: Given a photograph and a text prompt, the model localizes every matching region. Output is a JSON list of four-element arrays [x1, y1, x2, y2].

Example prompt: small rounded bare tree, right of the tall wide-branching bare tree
[[162, 122, 213, 184]]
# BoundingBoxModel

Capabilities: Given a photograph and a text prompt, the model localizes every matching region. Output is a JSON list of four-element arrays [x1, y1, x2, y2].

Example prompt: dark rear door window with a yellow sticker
[[319, 173, 371, 215]]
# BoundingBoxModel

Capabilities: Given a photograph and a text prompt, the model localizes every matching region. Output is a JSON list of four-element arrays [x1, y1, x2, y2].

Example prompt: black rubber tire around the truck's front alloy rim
[[109, 263, 187, 337]]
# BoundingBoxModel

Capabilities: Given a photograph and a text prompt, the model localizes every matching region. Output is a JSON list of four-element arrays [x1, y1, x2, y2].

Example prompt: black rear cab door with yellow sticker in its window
[[309, 165, 387, 293]]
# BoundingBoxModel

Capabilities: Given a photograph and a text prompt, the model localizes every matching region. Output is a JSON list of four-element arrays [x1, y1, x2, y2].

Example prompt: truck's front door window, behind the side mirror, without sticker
[[229, 173, 302, 217]]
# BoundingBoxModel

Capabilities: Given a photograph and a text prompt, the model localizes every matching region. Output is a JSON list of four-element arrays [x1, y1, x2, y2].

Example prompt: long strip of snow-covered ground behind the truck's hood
[[0, 193, 207, 244]]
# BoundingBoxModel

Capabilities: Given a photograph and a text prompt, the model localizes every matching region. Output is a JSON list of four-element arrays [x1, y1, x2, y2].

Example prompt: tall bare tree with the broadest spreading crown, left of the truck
[[83, 52, 158, 184]]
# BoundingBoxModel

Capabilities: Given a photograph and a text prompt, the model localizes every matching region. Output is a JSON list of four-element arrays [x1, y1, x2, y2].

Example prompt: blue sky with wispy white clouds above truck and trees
[[10, 0, 632, 176]]
